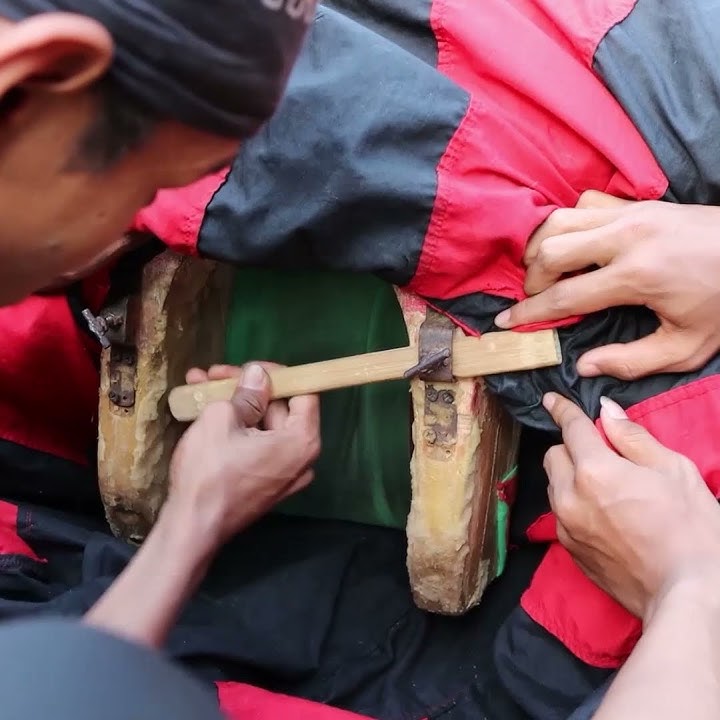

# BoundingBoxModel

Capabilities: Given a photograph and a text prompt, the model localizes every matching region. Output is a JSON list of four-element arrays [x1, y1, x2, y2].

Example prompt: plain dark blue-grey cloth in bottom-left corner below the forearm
[[0, 619, 221, 720]]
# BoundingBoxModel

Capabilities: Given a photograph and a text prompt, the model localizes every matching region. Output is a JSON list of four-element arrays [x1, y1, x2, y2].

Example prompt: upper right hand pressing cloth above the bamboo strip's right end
[[496, 191, 720, 380]]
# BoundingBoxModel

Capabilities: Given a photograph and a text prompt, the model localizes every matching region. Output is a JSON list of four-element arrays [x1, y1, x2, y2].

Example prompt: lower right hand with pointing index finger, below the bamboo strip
[[544, 394, 720, 620]]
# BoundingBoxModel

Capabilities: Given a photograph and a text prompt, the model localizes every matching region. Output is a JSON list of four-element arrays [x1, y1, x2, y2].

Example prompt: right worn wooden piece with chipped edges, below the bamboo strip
[[398, 291, 519, 615]]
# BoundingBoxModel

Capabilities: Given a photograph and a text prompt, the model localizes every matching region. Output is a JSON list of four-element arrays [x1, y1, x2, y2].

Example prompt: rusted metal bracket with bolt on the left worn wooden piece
[[83, 298, 138, 408]]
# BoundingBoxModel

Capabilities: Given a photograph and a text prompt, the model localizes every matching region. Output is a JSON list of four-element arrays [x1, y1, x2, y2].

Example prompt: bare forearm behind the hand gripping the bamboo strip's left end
[[85, 506, 216, 647]]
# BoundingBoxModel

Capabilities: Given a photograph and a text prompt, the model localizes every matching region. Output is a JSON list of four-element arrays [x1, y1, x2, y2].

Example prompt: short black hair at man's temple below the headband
[[66, 76, 160, 172]]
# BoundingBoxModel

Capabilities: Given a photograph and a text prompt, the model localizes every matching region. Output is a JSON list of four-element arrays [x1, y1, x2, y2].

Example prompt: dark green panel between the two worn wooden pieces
[[225, 268, 411, 528]]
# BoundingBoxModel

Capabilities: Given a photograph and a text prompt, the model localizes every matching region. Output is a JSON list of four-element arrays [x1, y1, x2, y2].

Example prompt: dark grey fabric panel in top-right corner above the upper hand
[[594, 0, 720, 204]]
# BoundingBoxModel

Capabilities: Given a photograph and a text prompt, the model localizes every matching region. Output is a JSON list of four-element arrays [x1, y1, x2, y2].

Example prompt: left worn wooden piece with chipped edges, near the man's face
[[98, 252, 232, 541]]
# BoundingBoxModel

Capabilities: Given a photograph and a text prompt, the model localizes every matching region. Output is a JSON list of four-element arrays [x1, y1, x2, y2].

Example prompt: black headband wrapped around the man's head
[[0, 0, 316, 138]]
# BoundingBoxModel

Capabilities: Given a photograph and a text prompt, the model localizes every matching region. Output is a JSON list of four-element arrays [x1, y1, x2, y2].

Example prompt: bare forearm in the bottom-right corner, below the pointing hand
[[595, 579, 720, 720]]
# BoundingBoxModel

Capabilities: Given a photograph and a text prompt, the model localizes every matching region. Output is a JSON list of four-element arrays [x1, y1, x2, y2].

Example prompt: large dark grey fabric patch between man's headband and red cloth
[[198, 7, 469, 285]]
